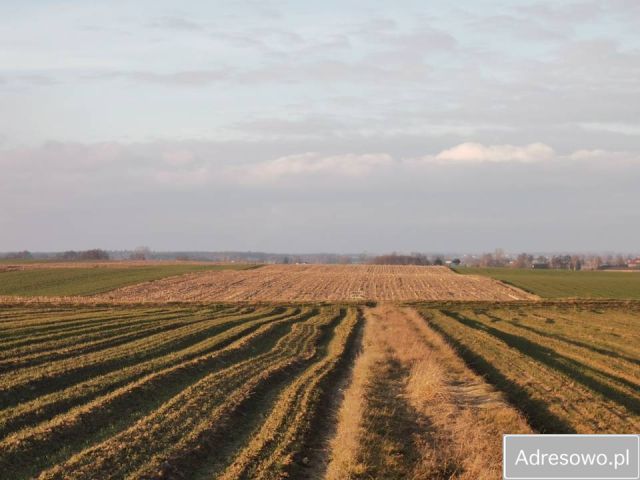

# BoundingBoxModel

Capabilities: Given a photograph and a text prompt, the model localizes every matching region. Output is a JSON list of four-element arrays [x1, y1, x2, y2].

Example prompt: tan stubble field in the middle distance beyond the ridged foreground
[[92, 265, 538, 302]]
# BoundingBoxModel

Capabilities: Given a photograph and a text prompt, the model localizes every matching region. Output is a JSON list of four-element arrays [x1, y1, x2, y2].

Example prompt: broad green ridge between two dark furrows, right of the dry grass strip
[[428, 311, 639, 433]]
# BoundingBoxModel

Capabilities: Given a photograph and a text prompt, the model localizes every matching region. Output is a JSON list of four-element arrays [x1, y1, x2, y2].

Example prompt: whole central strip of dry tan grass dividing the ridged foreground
[[327, 304, 530, 480]]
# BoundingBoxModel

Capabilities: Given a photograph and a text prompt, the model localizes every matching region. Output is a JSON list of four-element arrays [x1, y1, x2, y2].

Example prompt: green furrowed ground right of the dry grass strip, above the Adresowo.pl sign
[[418, 303, 640, 433]]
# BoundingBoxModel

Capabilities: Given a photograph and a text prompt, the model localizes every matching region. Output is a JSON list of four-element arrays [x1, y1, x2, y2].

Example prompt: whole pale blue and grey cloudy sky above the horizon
[[0, 0, 640, 253]]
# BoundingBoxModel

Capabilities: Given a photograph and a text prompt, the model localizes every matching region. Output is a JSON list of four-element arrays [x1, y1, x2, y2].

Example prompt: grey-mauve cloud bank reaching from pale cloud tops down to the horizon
[[0, 141, 640, 251]]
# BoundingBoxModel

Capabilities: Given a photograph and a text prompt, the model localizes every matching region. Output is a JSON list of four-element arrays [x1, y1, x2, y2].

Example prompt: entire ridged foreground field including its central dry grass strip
[[0, 301, 640, 480]]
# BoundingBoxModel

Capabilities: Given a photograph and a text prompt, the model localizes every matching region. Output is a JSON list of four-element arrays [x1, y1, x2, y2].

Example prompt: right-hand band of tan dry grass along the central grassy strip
[[394, 310, 531, 480]]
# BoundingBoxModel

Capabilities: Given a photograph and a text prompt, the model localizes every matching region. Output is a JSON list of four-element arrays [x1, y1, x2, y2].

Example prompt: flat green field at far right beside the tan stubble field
[[455, 267, 640, 300]]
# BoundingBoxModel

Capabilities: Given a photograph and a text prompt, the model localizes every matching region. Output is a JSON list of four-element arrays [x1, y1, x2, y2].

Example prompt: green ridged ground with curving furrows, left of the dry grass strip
[[0, 305, 361, 480]]
